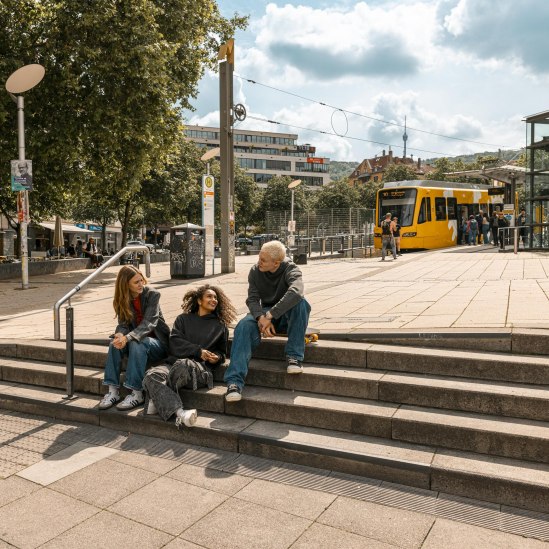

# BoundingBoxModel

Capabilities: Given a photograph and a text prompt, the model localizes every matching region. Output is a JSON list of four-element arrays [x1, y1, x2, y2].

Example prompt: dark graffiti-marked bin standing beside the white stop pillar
[[170, 223, 206, 278]]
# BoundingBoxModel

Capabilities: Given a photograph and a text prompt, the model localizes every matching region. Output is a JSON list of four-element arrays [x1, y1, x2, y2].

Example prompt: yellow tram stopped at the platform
[[374, 181, 503, 250]]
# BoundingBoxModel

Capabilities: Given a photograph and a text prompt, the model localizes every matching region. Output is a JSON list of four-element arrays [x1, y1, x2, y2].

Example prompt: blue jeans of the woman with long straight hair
[[103, 337, 168, 391]]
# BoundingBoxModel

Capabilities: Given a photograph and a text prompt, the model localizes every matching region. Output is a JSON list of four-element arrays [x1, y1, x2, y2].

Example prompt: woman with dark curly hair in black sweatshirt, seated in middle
[[143, 284, 236, 428]]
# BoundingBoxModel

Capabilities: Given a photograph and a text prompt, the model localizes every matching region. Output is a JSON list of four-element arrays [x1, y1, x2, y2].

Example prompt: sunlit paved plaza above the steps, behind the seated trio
[[0, 246, 549, 339]]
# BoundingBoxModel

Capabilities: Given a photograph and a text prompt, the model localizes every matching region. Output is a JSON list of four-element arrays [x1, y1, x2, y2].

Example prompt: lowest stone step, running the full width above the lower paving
[[0, 382, 549, 512]]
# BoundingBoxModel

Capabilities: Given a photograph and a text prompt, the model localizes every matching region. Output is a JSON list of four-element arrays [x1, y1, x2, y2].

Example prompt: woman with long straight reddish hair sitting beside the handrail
[[99, 265, 170, 410]]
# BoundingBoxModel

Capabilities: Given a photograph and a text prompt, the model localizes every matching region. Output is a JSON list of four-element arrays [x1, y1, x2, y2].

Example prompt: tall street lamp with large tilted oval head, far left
[[6, 64, 46, 290]]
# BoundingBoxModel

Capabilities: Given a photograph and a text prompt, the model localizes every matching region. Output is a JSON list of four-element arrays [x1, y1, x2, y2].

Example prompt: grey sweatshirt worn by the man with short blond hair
[[246, 258, 304, 319]]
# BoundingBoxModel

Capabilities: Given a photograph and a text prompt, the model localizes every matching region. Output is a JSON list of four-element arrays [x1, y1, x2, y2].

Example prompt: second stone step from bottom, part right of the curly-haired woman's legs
[[182, 386, 549, 463]]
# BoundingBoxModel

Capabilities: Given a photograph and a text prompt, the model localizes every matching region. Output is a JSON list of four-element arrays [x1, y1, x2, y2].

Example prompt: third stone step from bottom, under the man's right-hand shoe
[[215, 359, 549, 421]]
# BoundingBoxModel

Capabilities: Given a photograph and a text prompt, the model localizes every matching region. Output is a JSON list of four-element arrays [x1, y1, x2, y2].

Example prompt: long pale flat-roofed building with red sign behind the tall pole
[[185, 126, 330, 190]]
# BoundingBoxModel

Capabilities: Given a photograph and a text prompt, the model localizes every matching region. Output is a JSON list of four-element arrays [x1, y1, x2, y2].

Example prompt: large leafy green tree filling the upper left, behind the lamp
[[0, 0, 246, 248]]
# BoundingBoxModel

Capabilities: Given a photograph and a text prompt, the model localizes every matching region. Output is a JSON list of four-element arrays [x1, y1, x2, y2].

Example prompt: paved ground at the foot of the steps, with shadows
[[0, 411, 549, 549]]
